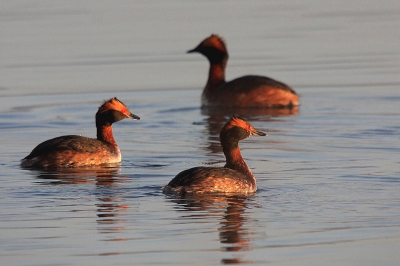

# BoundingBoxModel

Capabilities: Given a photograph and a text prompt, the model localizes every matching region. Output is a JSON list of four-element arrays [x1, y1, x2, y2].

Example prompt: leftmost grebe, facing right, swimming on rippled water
[[21, 98, 140, 168]]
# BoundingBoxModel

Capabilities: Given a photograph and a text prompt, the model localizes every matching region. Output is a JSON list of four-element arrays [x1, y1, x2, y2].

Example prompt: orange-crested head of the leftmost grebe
[[96, 97, 140, 126]]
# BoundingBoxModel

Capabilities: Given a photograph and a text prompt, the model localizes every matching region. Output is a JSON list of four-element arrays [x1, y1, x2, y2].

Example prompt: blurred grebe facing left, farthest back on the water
[[188, 34, 299, 108]]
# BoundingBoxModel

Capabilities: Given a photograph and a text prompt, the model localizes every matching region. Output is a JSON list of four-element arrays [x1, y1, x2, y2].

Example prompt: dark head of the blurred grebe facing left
[[188, 34, 228, 64]]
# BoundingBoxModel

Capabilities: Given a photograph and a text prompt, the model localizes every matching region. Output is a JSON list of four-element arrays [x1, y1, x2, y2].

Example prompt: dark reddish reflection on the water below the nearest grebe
[[168, 195, 254, 264]]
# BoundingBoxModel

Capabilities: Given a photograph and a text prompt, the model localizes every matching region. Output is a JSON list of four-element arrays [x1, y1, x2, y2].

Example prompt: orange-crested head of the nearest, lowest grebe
[[220, 116, 267, 143]]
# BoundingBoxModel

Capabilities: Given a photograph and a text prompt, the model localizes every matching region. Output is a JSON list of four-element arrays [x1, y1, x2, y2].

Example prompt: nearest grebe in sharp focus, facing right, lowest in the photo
[[163, 116, 266, 195]]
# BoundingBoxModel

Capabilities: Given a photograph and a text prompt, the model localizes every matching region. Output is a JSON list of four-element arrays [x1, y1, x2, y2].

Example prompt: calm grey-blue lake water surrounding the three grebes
[[0, 0, 400, 265]]
